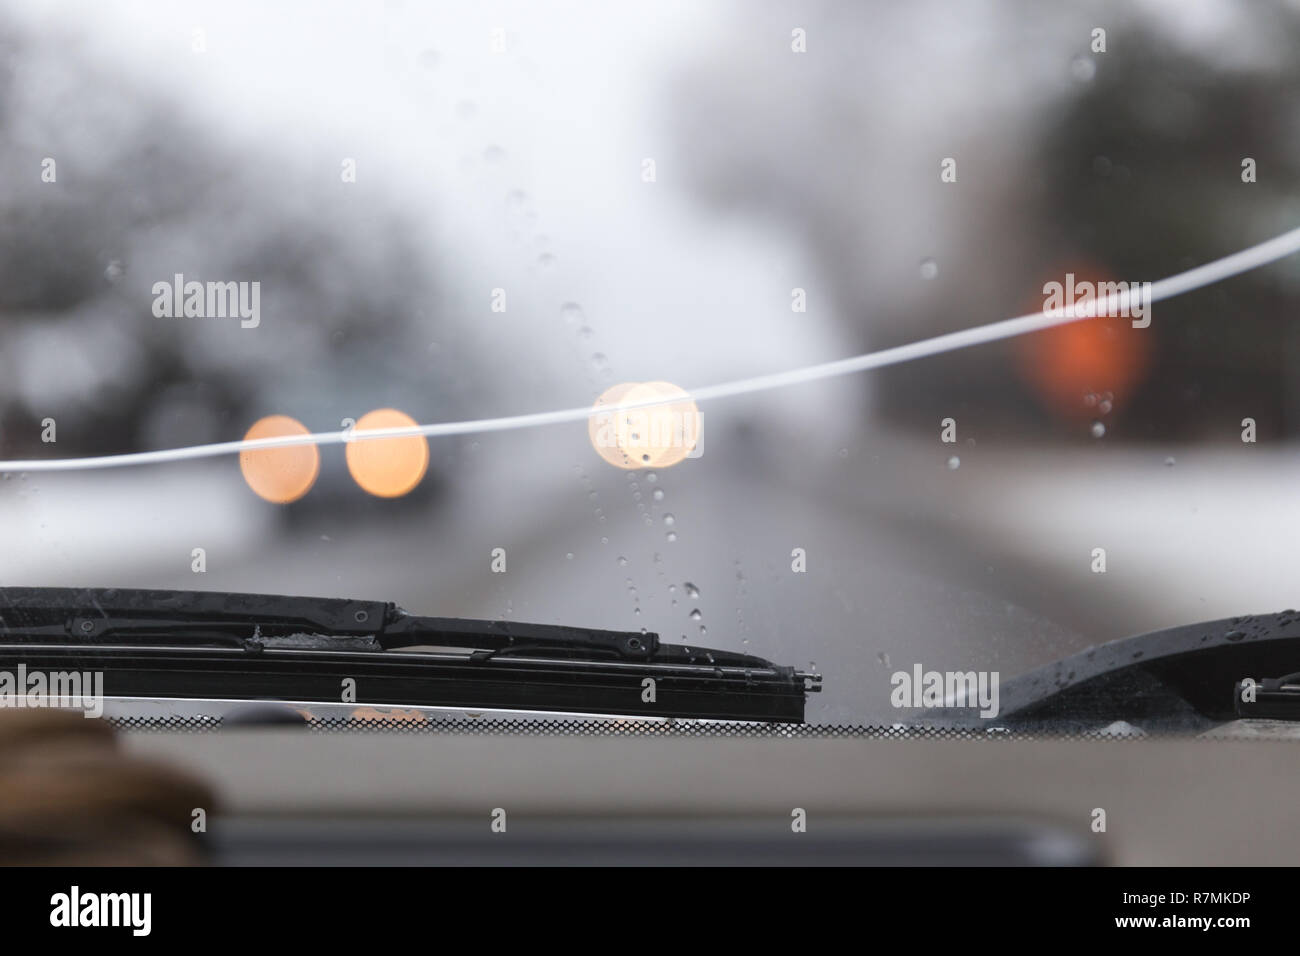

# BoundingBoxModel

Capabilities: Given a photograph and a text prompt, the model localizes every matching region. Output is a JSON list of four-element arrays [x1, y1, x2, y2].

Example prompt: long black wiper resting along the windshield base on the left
[[0, 588, 822, 722]]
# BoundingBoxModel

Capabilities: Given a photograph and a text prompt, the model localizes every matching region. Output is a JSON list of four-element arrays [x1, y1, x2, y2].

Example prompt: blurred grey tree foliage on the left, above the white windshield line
[[0, 14, 472, 509]]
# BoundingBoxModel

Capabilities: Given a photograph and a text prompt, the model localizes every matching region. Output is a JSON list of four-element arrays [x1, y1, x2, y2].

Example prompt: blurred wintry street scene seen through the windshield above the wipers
[[0, 0, 1300, 722]]
